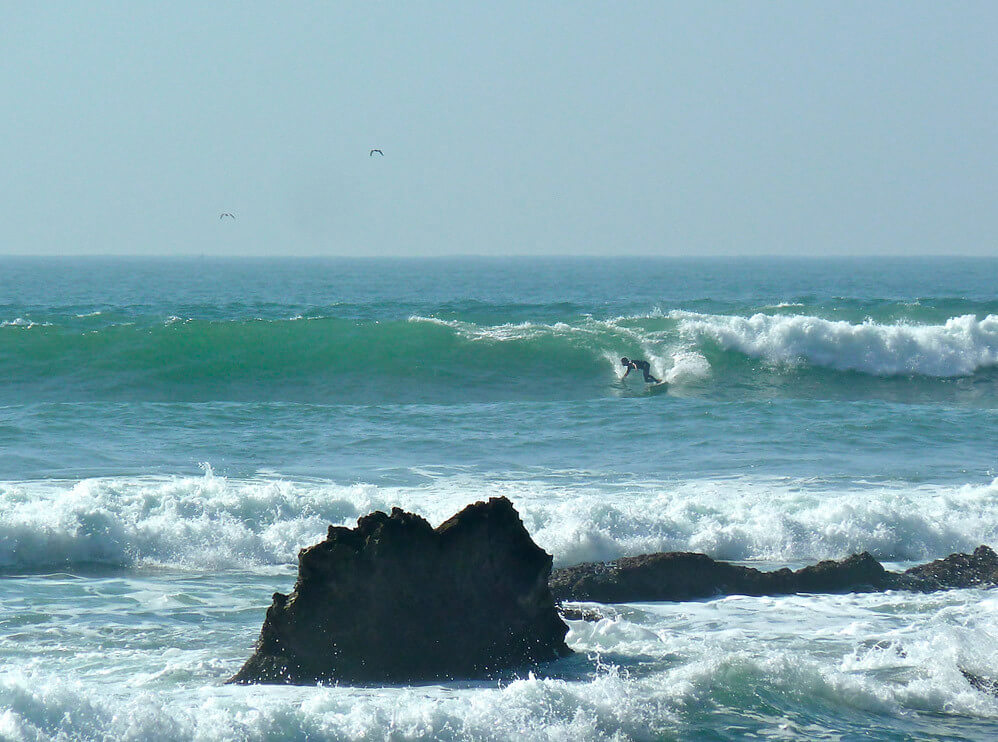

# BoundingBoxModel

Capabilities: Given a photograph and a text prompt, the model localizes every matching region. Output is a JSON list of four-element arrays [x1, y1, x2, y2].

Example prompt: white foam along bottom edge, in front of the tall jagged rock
[[0, 673, 674, 742]]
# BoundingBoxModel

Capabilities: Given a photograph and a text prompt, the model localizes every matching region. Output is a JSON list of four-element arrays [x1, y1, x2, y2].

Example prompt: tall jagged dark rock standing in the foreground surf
[[230, 497, 571, 684]]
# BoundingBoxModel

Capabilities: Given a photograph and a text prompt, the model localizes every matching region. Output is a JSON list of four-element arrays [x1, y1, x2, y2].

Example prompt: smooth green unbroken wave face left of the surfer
[[0, 318, 640, 403]]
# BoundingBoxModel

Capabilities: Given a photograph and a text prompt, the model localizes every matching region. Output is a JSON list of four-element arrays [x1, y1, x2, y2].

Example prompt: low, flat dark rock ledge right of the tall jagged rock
[[551, 546, 998, 603]]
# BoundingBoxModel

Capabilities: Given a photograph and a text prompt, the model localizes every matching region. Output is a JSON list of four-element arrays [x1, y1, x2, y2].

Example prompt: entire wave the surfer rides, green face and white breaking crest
[[0, 307, 998, 402]]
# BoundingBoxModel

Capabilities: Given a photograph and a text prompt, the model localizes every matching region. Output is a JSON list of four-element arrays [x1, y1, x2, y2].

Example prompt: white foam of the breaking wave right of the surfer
[[670, 312, 998, 377]]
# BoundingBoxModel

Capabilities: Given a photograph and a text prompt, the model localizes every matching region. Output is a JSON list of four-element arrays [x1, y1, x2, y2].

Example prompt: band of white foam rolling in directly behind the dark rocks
[[0, 470, 998, 571]]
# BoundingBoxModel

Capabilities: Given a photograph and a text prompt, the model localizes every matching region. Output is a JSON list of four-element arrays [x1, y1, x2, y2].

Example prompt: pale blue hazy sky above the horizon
[[0, 0, 998, 255]]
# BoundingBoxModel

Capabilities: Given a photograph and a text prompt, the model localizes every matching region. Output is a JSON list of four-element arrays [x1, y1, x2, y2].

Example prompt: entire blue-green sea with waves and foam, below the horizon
[[0, 258, 998, 741]]
